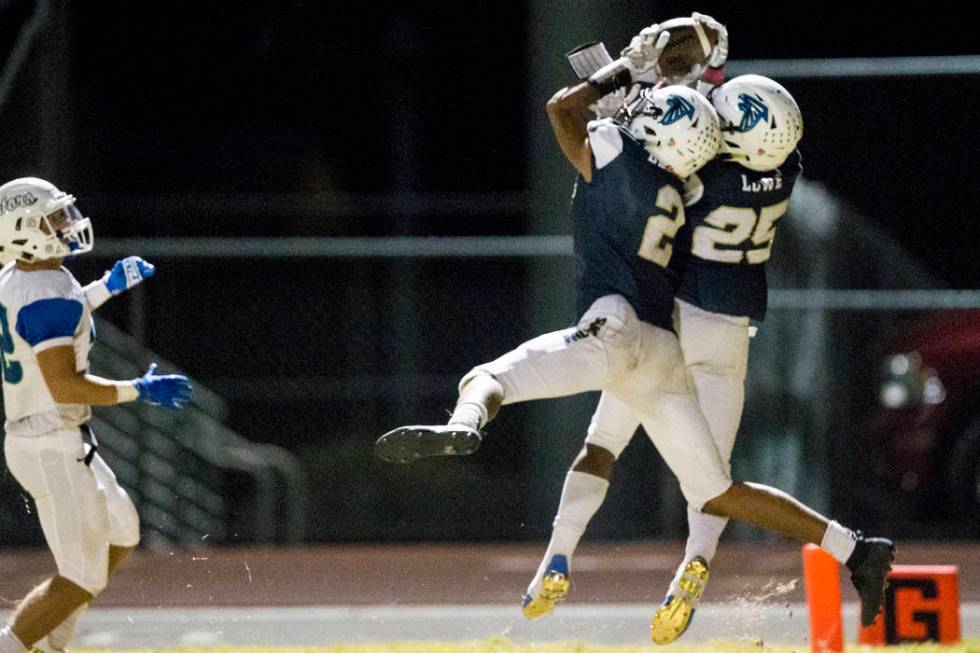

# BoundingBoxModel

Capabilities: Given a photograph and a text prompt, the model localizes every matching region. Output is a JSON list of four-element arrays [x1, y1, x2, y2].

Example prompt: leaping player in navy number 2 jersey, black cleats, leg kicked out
[[376, 26, 892, 640]]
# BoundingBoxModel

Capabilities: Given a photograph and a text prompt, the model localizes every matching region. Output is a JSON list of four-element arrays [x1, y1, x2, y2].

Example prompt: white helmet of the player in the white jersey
[[0, 177, 93, 263]]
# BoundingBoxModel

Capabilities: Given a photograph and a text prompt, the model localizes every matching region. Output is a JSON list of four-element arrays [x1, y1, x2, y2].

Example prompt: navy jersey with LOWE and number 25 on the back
[[672, 151, 802, 320]]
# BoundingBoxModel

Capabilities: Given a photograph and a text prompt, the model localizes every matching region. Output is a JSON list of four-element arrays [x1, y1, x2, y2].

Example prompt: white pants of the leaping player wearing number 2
[[460, 295, 732, 509]]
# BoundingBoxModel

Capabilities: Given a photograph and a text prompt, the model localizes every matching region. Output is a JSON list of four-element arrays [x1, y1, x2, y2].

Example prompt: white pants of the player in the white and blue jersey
[[4, 429, 140, 596]]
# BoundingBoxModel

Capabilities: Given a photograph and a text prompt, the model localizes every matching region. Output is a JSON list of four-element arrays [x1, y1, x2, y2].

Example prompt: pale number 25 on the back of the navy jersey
[[691, 200, 789, 265]]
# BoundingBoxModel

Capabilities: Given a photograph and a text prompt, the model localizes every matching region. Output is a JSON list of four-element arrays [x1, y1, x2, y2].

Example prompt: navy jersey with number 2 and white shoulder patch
[[572, 120, 684, 330]]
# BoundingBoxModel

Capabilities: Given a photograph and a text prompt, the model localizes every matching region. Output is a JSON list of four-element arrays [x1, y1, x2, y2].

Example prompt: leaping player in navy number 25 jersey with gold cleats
[[524, 13, 892, 644]]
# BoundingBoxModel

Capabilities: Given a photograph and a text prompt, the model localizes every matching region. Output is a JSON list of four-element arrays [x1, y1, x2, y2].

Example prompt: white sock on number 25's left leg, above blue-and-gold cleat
[[527, 471, 609, 596]]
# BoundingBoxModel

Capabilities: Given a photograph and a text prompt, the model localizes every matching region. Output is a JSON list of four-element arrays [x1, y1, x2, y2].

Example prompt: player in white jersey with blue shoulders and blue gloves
[[0, 177, 191, 653]]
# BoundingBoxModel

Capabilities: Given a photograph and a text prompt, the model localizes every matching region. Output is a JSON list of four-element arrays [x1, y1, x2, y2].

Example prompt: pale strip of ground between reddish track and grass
[[0, 602, 980, 648]]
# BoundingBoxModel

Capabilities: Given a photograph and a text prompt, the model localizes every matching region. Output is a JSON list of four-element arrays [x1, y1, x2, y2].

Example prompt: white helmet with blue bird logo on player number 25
[[711, 75, 803, 171]]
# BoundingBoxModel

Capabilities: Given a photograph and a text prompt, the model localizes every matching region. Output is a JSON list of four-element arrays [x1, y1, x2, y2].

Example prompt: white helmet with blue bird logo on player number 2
[[629, 86, 721, 179]]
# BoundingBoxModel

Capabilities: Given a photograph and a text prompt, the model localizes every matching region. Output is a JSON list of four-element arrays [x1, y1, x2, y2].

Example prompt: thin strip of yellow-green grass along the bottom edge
[[75, 639, 980, 653]]
